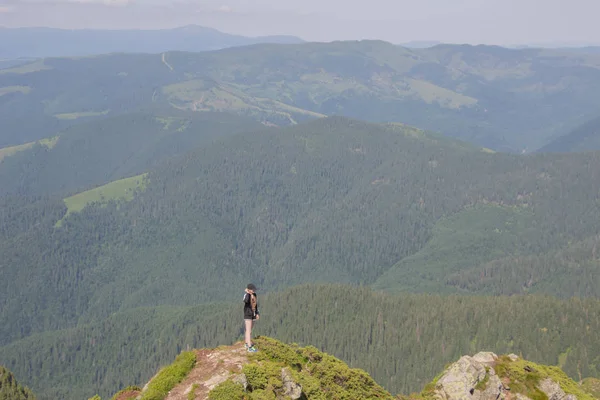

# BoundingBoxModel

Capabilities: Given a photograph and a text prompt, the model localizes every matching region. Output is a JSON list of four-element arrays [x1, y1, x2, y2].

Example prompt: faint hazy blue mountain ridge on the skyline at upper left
[[0, 25, 303, 59]]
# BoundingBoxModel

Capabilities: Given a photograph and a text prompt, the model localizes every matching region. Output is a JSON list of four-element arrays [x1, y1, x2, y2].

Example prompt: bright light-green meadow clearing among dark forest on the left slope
[[56, 174, 148, 227]]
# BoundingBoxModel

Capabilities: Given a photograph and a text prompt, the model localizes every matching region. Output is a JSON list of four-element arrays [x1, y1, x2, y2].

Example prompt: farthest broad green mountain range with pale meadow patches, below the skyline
[[0, 41, 600, 151]]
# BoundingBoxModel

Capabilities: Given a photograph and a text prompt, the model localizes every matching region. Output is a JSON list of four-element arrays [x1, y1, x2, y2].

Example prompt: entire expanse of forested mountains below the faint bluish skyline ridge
[[0, 36, 600, 400]]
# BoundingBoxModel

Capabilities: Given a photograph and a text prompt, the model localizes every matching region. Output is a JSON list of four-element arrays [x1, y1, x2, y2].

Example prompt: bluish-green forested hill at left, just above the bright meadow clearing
[[0, 108, 264, 196]]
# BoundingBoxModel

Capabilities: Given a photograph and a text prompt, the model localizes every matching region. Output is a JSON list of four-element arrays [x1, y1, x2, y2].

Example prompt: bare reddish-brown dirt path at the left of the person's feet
[[166, 342, 248, 400]]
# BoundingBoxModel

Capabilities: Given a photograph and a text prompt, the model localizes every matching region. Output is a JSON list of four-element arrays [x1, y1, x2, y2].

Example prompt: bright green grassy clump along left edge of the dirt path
[[141, 351, 196, 400]]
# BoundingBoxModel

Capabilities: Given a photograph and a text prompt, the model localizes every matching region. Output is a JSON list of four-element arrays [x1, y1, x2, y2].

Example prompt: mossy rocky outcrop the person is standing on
[[123, 336, 395, 400]]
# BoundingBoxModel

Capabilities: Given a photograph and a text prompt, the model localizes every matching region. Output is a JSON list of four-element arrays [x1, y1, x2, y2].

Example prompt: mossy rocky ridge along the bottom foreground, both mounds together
[[101, 337, 599, 400]]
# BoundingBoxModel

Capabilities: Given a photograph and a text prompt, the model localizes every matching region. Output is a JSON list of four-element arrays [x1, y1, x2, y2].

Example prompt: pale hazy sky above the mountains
[[0, 0, 600, 44]]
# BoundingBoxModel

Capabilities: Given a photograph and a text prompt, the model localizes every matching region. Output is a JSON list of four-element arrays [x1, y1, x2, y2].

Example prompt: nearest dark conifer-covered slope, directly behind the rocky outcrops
[[0, 285, 600, 400]]
